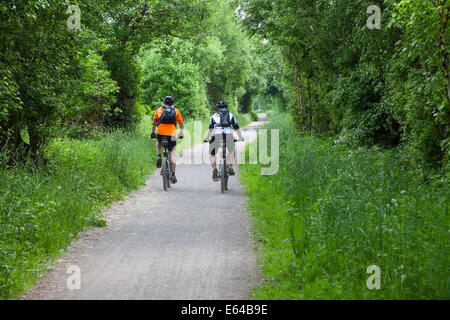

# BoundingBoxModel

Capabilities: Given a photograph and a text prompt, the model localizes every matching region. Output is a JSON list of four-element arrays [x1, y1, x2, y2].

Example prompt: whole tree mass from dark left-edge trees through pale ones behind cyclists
[[0, 0, 266, 163]]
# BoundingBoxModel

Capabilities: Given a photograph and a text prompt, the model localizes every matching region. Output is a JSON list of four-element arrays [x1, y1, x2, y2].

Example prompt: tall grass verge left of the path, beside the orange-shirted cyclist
[[0, 130, 156, 299]]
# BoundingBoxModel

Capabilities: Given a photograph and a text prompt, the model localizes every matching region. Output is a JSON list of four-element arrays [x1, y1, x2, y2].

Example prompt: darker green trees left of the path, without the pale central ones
[[0, 0, 230, 164]]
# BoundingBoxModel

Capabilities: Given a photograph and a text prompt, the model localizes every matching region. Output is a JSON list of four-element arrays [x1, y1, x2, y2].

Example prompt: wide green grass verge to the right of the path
[[241, 115, 450, 299]]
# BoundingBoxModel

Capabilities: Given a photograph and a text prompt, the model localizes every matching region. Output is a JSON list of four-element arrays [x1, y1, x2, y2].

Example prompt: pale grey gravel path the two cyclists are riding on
[[22, 117, 265, 299]]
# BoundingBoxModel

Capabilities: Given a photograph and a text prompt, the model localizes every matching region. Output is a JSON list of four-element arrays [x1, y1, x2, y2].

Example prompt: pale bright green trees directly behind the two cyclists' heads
[[140, 1, 268, 118]]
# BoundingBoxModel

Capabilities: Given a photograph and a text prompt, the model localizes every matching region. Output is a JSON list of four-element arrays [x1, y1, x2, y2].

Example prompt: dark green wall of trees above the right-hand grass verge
[[235, 0, 450, 168]]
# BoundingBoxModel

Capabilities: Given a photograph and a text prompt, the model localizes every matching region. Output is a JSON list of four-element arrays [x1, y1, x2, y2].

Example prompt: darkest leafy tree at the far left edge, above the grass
[[0, 0, 84, 161]]
